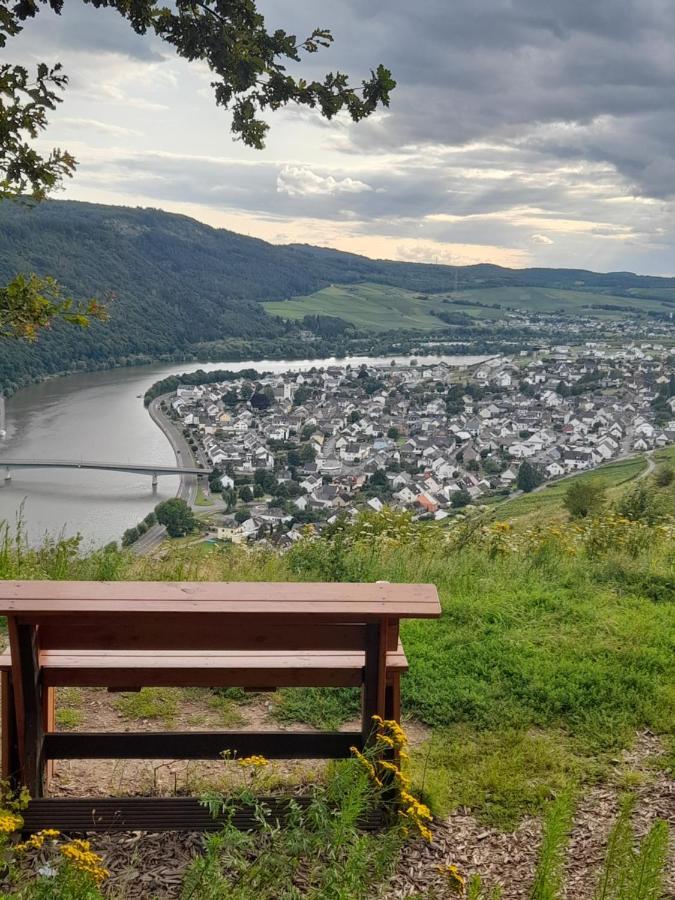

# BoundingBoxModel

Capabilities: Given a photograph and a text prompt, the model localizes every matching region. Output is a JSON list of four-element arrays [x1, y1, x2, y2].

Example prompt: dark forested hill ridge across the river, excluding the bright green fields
[[0, 201, 675, 391]]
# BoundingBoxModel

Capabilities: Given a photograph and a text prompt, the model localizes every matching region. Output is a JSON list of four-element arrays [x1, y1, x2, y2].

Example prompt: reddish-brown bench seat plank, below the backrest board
[[0, 641, 408, 690]]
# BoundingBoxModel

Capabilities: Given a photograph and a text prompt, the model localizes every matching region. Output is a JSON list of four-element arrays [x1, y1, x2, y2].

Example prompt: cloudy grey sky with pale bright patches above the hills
[[3, 0, 675, 275]]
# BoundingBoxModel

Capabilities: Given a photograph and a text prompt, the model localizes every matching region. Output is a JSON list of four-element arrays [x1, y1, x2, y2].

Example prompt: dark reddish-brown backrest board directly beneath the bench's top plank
[[35, 613, 365, 651]]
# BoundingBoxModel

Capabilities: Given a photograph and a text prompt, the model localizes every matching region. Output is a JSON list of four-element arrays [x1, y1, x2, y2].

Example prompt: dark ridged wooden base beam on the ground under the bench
[[23, 797, 382, 834]]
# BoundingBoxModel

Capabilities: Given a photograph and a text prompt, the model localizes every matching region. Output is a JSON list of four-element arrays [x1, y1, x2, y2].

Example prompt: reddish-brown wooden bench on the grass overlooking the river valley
[[0, 581, 440, 821]]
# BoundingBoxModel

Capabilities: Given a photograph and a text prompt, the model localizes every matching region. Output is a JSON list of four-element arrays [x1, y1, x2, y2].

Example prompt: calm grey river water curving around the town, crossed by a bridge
[[0, 356, 485, 547]]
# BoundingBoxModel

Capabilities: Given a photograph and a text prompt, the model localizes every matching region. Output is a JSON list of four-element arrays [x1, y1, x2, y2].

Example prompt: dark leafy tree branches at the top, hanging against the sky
[[0, 0, 396, 199]]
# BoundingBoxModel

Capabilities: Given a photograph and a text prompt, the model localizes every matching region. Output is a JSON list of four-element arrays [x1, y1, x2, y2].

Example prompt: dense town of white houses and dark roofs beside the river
[[161, 342, 675, 548]]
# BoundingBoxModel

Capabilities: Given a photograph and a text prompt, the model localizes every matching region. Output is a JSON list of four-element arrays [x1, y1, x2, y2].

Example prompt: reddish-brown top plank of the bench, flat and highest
[[0, 581, 440, 621]]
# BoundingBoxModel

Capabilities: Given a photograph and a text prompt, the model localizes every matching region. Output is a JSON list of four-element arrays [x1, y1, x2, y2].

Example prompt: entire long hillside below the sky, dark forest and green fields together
[[0, 201, 675, 392]]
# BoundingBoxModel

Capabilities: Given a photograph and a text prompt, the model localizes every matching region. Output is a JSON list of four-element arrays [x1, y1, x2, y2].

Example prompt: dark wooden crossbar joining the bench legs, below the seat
[[44, 731, 362, 759]]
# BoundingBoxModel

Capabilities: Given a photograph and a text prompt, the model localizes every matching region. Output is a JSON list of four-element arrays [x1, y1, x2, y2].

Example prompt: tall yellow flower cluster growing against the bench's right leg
[[351, 716, 432, 841]]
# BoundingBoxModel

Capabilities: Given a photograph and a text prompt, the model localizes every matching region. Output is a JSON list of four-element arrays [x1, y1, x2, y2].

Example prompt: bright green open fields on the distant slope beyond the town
[[263, 282, 675, 331]]
